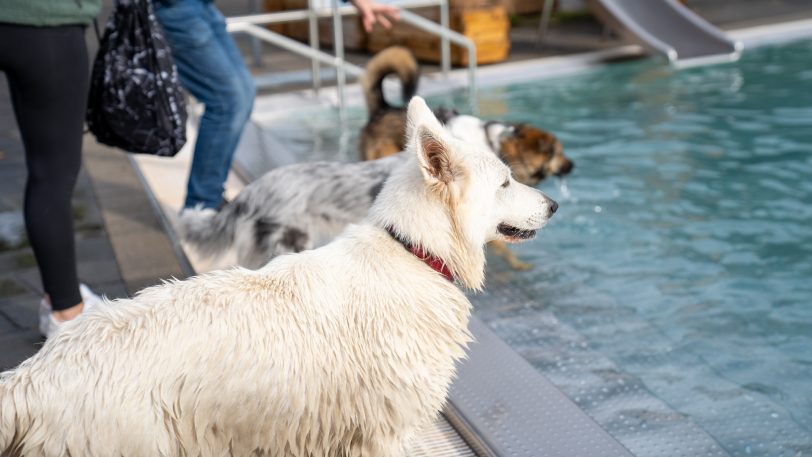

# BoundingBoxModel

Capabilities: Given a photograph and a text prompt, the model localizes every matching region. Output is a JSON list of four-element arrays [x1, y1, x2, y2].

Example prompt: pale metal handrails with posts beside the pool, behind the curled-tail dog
[[227, 0, 477, 112]]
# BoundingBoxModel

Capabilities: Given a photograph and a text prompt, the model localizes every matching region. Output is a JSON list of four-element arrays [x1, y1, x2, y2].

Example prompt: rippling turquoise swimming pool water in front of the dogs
[[244, 37, 812, 457]]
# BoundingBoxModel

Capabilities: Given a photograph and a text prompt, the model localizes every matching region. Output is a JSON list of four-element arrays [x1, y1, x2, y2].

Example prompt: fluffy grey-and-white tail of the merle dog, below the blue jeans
[[178, 203, 239, 258]]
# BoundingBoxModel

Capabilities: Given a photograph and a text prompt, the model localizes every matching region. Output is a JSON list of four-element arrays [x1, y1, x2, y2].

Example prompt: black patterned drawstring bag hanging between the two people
[[86, 0, 186, 156]]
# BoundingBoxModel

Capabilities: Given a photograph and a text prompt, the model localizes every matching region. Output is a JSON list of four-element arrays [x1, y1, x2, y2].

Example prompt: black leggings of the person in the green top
[[0, 24, 89, 310]]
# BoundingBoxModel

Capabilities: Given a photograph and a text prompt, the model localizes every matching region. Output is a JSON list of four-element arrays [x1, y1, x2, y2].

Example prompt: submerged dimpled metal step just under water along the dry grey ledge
[[472, 282, 732, 457]]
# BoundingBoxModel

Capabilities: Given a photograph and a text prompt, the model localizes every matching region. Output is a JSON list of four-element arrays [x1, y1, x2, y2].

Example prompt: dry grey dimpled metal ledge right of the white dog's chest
[[449, 318, 631, 457]]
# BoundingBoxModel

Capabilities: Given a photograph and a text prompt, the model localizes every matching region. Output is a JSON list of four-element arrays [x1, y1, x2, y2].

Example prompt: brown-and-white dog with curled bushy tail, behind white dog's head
[[359, 46, 573, 269]]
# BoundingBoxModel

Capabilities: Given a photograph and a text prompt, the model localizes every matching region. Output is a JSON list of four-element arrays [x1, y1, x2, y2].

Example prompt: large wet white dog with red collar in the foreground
[[0, 98, 556, 457]]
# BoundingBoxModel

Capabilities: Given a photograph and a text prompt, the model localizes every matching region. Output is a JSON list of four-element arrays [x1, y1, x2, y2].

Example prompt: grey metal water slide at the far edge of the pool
[[588, 0, 742, 66]]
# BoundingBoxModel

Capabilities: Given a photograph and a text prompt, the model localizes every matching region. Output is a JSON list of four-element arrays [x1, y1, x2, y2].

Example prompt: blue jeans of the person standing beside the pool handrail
[[154, 0, 256, 208]]
